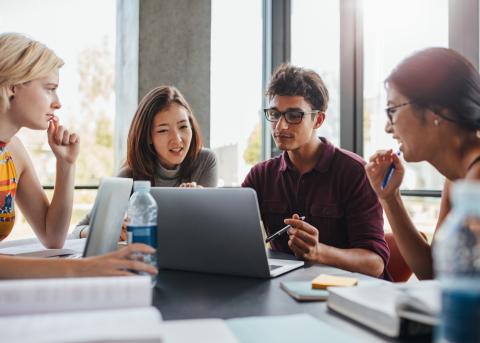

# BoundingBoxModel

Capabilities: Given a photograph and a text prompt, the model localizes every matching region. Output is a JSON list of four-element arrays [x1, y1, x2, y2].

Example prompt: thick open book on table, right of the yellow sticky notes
[[327, 281, 440, 337]]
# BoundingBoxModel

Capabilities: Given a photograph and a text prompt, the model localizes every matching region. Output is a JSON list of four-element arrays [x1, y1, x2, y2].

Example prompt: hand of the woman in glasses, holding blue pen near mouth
[[365, 149, 405, 199]]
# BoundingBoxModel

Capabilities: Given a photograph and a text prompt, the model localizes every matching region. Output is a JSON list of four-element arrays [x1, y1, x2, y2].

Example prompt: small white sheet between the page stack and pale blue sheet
[[163, 319, 238, 343]]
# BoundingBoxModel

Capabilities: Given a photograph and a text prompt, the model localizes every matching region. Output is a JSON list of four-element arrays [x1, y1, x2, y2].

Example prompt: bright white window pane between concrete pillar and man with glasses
[[210, 0, 262, 186]]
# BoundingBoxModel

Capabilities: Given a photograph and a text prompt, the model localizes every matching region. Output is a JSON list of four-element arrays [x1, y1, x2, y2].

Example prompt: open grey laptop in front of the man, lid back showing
[[151, 187, 304, 278]]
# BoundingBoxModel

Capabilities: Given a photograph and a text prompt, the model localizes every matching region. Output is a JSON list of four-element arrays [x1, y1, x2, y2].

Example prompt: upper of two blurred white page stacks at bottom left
[[0, 276, 152, 318]]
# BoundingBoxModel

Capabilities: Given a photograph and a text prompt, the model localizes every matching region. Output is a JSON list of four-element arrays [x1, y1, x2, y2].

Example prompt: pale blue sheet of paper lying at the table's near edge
[[226, 314, 359, 343]]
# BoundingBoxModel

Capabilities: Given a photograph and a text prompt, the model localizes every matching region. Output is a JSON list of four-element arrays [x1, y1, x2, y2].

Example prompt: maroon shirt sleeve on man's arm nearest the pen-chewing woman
[[345, 164, 390, 269]]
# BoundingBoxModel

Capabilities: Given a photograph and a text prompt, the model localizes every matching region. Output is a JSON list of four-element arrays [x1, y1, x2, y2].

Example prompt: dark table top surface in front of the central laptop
[[153, 253, 432, 342]]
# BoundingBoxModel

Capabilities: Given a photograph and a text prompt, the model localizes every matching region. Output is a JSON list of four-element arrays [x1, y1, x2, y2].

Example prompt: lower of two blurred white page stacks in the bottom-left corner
[[0, 307, 163, 343]]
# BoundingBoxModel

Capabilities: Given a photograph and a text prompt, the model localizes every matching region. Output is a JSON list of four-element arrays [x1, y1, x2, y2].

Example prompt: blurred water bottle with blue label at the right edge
[[433, 181, 480, 343]]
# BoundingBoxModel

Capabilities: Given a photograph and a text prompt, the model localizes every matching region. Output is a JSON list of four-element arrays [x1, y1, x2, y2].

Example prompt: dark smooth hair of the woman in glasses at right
[[385, 48, 480, 131]]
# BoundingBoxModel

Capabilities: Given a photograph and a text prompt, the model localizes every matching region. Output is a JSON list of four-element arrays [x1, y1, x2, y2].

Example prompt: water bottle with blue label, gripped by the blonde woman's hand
[[127, 181, 157, 285]]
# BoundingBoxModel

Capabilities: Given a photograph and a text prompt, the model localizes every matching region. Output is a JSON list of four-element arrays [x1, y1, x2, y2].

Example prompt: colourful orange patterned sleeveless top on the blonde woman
[[0, 142, 17, 241]]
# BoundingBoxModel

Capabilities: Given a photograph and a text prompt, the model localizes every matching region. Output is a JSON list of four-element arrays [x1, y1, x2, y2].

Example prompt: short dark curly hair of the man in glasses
[[266, 64, 328, 112]]
